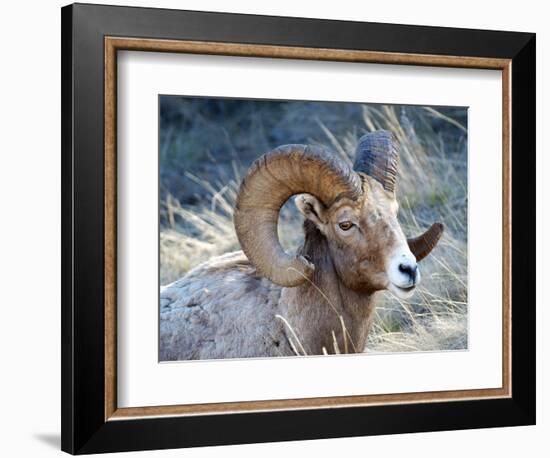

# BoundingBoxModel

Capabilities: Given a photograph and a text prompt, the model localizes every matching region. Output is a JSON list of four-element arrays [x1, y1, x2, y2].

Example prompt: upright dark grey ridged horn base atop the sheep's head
[[353, 130, 399, 193]]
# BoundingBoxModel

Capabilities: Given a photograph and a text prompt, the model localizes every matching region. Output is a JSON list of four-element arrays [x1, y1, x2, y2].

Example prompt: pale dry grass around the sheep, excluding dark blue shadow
[[160, 101, 468, 354]]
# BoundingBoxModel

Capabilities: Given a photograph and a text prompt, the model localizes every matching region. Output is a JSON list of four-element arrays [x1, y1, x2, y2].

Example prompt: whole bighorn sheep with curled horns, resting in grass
[[160, 131, 443, 361]]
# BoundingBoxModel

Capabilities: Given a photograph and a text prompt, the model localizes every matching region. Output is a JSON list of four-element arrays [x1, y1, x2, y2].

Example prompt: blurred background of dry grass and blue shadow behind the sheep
[[159, 96, 468, 352]]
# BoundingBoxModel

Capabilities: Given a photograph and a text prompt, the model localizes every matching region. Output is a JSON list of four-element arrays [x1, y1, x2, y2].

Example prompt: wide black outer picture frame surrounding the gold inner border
[[61, 4, 536, 454]]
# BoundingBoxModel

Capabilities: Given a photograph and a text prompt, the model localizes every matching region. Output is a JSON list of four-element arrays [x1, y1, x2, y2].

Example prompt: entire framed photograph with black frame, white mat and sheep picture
[[62, 4, 535, 454]]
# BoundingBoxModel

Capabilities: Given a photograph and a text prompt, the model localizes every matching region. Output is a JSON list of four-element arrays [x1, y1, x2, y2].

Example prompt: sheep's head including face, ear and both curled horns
[[235, 131, 443, 297]]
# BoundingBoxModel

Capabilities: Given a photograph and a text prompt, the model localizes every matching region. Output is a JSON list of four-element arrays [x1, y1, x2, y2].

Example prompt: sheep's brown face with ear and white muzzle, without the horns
[[296, 177, 420, 298]]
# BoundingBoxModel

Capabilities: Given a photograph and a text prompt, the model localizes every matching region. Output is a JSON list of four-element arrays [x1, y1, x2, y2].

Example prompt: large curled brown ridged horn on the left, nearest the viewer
[[234, 145, 362, 287]]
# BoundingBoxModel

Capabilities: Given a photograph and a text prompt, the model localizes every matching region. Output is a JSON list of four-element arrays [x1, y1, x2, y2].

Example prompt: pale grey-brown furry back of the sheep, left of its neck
[[160, 251, 293, 361]]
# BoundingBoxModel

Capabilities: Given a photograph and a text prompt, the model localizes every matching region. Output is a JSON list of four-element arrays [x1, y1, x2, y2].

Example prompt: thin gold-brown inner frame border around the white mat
[[104, 37, 512, 421]]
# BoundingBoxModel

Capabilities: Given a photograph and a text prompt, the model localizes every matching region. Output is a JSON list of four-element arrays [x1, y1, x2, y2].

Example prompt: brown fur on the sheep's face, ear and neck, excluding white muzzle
[[280, 177, 406, 354]]
